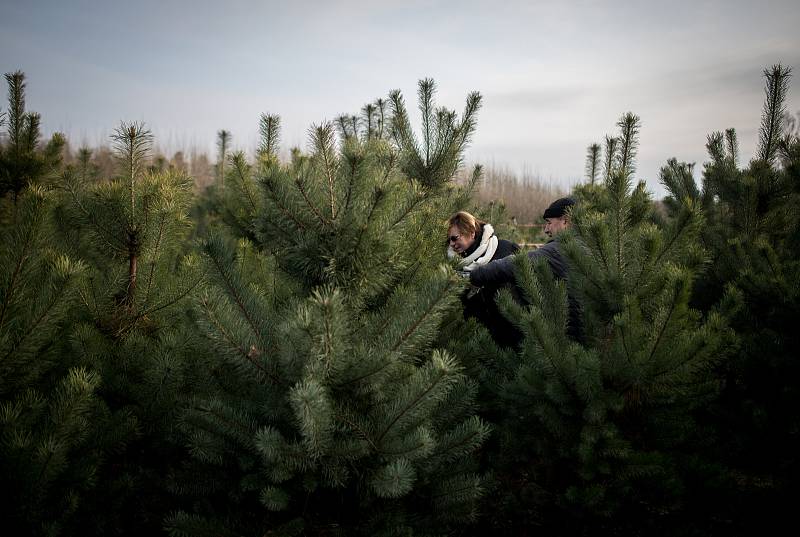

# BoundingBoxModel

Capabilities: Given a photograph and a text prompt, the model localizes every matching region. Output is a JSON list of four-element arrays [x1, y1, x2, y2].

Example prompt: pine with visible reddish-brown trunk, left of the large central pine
[[60, 123, 200, 535]]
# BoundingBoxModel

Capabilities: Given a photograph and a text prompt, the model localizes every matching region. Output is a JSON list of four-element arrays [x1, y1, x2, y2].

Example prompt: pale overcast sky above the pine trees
[[0, 0, 800, 195]]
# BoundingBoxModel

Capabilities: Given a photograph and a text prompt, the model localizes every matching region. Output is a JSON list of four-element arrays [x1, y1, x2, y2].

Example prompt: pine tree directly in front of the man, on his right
[[478, 113, 730, 533]]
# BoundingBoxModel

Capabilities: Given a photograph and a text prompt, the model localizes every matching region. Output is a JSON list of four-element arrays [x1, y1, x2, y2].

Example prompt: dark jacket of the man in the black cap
[[469, 239, 583, 341]]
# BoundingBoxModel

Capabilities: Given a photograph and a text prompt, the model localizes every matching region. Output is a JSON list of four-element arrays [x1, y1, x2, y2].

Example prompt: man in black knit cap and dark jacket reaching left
[[469, 198, 582, 341]]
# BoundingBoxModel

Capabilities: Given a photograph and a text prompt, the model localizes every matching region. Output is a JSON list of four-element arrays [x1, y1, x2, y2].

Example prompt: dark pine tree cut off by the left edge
[[0, 73, 132, 535]]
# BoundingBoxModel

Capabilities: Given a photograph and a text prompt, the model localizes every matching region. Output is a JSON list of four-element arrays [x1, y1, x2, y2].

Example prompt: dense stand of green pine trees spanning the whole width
[[0, 66, 800, 536]]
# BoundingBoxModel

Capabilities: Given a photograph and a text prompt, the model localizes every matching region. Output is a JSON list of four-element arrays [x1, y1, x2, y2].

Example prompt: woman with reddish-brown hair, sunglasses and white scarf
[[447, 211, 521, 347]]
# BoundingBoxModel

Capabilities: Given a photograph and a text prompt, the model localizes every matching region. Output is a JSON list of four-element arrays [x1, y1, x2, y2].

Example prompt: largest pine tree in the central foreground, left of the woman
[[168, 81, 488, 535]]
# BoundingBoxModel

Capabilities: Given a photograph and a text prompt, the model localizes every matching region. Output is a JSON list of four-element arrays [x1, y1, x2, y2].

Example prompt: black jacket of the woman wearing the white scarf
[[461, 230, 521, 347]]
